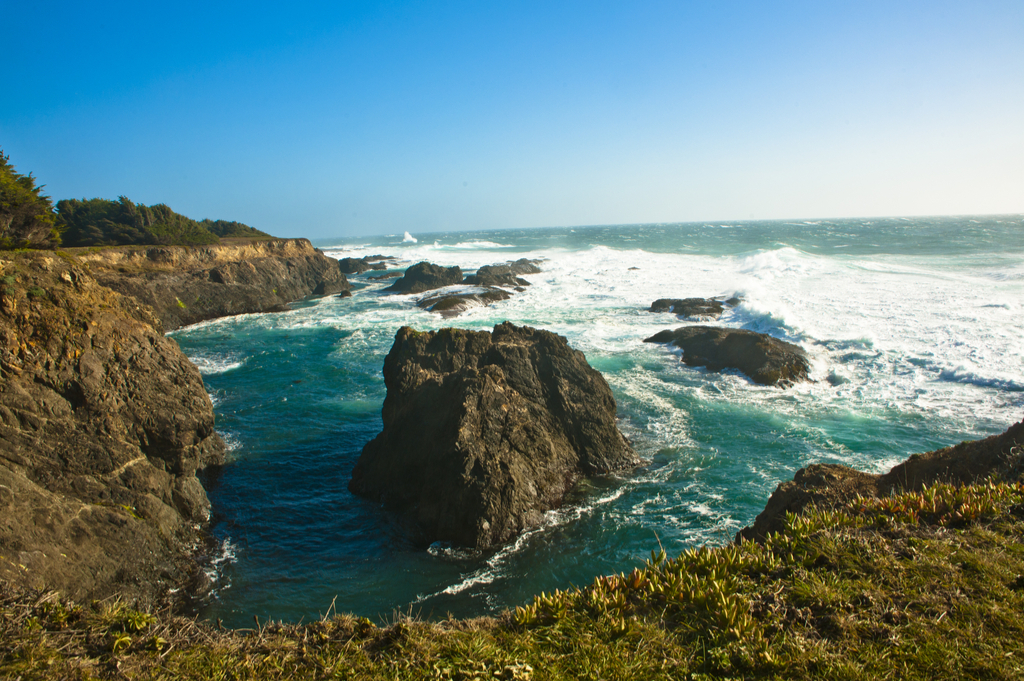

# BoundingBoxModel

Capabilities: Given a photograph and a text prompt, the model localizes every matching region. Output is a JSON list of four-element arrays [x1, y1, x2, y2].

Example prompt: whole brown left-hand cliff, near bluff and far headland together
[[0, 239, 349, 603]]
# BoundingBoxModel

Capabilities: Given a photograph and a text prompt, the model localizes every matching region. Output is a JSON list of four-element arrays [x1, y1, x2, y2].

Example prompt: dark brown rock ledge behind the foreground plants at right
[[736, 422, 1024, 542]]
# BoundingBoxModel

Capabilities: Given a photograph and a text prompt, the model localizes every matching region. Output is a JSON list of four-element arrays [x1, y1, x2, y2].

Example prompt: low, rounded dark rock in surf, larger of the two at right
[[644, 326, 810, 387]]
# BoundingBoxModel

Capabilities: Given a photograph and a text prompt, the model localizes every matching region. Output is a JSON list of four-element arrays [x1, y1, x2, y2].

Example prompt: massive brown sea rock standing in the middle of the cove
[[349, 323, 637, 548]]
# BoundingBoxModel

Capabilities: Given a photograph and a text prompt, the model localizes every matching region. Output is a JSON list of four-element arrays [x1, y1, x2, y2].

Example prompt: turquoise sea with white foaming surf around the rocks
[[172, 216, 1024, 627]]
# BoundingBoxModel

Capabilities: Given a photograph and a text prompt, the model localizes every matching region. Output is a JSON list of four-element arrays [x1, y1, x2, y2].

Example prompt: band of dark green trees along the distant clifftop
[[0, 150, 270, 249]]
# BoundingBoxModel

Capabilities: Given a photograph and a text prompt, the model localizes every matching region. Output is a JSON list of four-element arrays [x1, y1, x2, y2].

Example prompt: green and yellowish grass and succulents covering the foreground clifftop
[[0, 483, 1024, 680]]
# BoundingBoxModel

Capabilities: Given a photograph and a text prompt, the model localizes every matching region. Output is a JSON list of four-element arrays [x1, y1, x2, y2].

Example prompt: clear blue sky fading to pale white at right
[[0, 0, 1024, 238]]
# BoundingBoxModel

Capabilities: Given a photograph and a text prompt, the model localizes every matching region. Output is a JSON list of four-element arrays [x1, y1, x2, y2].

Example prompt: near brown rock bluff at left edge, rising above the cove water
[[0, 252, 223, 601]]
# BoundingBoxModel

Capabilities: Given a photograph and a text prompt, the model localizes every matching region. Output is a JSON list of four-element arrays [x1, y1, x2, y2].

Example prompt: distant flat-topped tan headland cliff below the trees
[[73, 239, 349, 331]]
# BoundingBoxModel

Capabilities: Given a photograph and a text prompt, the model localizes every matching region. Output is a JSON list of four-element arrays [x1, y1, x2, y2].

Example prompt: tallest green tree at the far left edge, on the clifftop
[[0, 150, 60, 249]]
